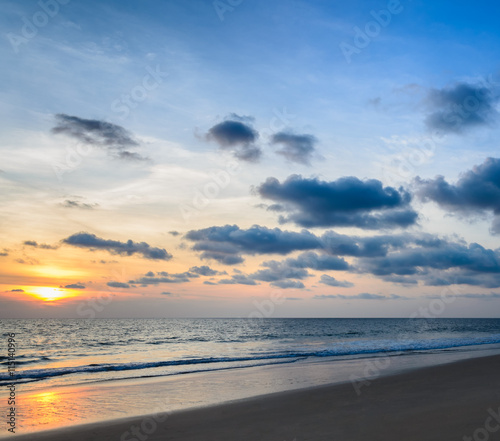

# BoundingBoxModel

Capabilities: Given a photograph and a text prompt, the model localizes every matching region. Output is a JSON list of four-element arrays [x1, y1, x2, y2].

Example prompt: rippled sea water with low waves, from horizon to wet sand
[[0, 319, 500, 390]]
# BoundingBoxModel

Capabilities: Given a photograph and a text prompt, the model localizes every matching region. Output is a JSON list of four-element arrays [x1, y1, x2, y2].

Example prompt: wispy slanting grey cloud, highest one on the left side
[[52, 113, 146, 160]]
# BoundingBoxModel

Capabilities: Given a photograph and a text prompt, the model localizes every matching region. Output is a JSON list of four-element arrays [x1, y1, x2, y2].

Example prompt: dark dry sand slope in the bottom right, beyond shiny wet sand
[[15, 355, 500, 441]]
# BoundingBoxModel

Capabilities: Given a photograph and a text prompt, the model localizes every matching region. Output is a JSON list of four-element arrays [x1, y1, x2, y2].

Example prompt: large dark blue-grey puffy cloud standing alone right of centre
[[256, 175, 418, 229]]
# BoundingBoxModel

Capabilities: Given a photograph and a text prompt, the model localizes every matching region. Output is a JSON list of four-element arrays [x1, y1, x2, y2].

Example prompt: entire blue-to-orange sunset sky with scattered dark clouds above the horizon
[[0, 0, 500, 318]]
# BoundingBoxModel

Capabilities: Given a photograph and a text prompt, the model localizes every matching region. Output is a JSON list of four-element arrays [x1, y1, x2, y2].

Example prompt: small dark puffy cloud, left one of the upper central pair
[[205, 114, 262, 162]]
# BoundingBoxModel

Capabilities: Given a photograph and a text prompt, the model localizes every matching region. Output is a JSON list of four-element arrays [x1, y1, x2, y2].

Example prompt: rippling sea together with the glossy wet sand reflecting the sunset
[[0, 318, 500, 431]]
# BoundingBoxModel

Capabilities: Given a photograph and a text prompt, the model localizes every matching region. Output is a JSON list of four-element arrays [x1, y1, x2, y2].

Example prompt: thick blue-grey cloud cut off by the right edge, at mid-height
[[415, 158, 500, 234]]
